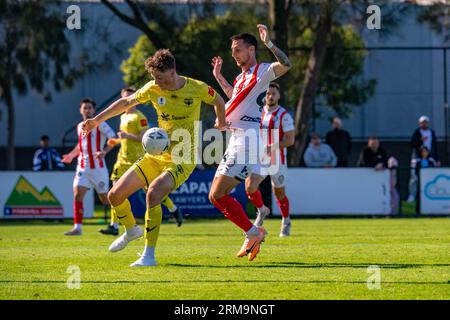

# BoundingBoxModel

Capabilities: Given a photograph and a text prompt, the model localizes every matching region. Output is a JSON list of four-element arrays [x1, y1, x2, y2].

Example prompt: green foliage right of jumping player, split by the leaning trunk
[[287, 21, 376, 117]]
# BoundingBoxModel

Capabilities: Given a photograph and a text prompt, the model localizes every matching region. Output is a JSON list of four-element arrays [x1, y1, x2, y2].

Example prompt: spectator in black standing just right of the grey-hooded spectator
[[325, 117, 352, 167]]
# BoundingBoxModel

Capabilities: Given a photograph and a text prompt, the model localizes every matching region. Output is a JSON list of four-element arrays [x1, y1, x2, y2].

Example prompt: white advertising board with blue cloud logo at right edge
[[420, 168, 450, 214]]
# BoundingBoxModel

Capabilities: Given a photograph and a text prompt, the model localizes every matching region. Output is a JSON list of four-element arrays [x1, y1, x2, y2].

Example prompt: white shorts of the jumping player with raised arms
[[215, 130, 259, 181]]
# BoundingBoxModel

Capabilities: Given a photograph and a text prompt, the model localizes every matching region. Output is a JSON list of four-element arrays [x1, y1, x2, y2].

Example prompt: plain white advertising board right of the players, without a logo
[[272, 168, 390, 215]]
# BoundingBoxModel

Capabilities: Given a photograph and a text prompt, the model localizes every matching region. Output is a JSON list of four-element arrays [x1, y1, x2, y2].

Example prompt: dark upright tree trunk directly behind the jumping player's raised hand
[[269, 0, 290, 104]]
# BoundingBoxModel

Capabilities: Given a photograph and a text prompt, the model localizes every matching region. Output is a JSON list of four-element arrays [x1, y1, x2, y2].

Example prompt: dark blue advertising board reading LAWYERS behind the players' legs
[[129, 169, 248, 217]]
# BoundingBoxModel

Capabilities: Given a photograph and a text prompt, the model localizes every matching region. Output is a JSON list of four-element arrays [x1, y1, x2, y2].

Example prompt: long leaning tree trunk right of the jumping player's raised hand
[[291, 2, 333, 166]]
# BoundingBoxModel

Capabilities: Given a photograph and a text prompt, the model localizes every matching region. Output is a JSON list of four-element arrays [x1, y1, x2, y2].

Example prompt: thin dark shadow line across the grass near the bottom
[[0, 279, 450, 285]]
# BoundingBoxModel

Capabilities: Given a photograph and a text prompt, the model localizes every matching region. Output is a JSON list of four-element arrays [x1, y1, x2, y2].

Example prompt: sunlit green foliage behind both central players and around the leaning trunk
[[121, 8, 376, 122]]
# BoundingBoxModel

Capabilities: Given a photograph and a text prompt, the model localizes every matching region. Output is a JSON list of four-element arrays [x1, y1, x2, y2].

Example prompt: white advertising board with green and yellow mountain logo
[[0, 171, 94, 219]]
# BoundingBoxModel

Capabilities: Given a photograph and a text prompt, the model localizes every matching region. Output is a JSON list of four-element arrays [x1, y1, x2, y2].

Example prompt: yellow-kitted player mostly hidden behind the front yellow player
[[99, 87, 183, 236]]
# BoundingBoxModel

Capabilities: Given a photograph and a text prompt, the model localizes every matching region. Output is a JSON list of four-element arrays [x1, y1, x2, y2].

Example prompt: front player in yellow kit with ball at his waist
[[83, 49, 227, 267]]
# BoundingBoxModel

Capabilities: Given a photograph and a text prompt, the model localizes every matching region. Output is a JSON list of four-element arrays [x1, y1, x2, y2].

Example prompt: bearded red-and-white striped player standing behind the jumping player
[[245, 82, 295, 237]]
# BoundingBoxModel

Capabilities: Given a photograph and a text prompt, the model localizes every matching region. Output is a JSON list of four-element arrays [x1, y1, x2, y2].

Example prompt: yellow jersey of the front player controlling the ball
[[136, 77, 217, 163]]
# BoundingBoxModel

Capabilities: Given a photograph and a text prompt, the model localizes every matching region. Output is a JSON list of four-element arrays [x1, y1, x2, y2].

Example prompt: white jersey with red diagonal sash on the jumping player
[[225, 63, 277, 130]]
